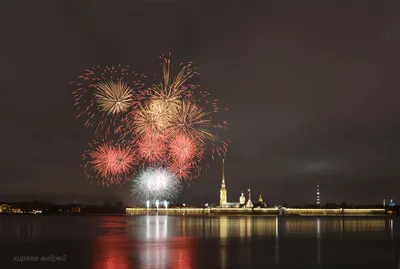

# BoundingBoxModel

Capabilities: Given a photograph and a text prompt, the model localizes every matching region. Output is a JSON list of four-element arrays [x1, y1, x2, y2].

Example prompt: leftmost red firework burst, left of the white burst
[[84, 142, 136, 186]]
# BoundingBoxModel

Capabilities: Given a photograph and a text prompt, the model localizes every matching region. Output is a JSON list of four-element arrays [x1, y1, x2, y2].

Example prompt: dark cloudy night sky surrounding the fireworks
[[0, 1, 400, 205]]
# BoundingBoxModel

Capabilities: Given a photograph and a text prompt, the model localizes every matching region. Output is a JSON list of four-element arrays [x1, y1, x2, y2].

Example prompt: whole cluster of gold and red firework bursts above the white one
[[74, 53, 229, 187]]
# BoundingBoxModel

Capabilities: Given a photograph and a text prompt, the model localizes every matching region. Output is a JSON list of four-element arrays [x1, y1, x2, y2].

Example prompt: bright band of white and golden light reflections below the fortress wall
[[130, 216, 394, 240]]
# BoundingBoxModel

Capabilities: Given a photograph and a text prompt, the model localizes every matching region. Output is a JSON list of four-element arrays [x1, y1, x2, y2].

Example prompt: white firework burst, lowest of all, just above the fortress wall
[[131, 167, 181, 202]]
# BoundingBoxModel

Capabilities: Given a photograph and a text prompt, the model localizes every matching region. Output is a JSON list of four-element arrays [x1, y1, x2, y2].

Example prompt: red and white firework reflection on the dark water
[[92, 217, 196, 269]]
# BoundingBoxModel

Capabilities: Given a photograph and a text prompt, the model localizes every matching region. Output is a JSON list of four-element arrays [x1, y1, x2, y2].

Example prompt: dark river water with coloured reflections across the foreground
[[0, 215, 400, 269]]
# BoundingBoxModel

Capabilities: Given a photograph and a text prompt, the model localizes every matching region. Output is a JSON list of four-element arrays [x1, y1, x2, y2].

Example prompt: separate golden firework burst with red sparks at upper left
[[71, 65, 145, 137]]
